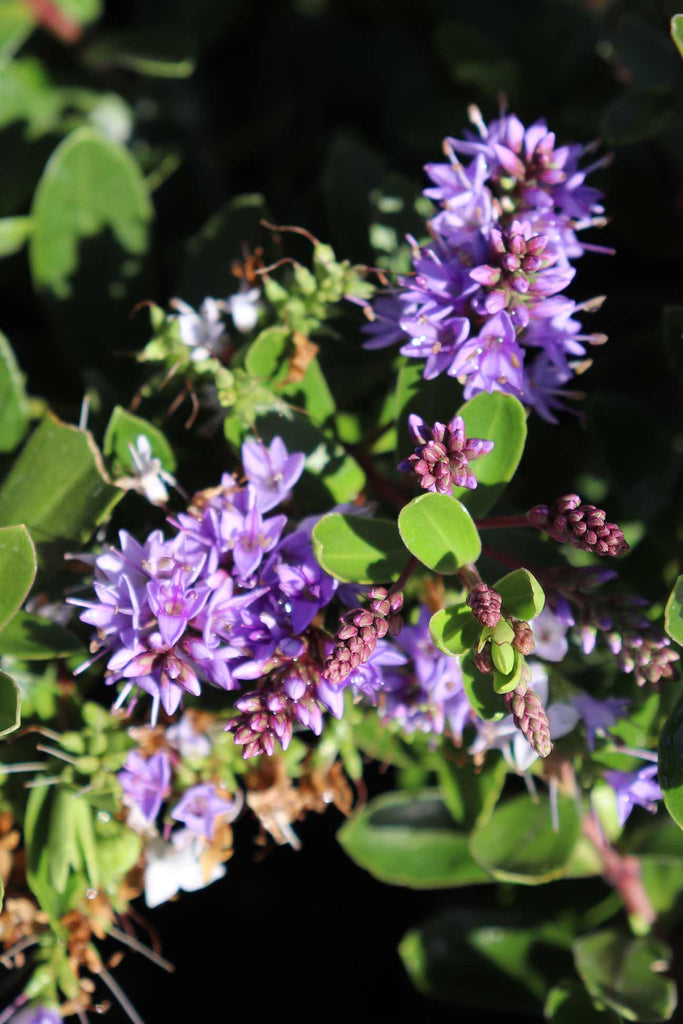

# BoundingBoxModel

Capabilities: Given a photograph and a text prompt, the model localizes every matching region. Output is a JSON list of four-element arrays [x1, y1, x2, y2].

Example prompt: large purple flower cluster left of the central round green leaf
[[73, 437, 337, 733]]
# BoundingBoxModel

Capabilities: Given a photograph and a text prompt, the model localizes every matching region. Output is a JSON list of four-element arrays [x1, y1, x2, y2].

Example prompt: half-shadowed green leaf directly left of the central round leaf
[[312, 512, 408, 584]]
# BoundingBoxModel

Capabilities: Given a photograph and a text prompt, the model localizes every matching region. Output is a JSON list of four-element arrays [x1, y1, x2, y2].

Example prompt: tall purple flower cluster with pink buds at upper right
[[366, 109, 608, 422]]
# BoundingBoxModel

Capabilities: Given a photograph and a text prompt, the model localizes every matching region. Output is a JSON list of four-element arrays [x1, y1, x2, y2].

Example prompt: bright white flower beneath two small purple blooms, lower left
[[144, 828, 225, 908]]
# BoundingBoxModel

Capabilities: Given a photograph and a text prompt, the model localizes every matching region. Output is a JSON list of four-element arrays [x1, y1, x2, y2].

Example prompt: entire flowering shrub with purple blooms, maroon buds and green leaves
[[0, 8, 683, 1024]]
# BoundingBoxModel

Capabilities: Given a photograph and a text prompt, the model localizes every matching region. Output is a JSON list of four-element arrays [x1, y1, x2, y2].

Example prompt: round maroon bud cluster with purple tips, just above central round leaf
[[398, 414, 494, 495]]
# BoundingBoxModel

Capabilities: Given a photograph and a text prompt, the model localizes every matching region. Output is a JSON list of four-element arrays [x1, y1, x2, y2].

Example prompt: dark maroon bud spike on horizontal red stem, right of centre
[[526, 495, 629, 557]]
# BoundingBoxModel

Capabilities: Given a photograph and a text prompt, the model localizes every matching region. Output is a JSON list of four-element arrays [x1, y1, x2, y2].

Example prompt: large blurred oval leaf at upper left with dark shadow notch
[[29, 128, 153, 299]]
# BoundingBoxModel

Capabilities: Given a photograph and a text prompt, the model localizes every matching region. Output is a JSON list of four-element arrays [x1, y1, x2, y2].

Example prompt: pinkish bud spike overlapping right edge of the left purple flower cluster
[[323, 587, 403, 686]]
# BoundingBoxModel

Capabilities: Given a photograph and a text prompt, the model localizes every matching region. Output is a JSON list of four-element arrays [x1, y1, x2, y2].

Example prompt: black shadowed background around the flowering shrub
[[0, 0, 683, 1024]]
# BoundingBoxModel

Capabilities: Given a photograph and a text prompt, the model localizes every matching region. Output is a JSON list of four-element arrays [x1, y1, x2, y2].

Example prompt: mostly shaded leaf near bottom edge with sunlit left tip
[[398, 907, 570, 1020]]
